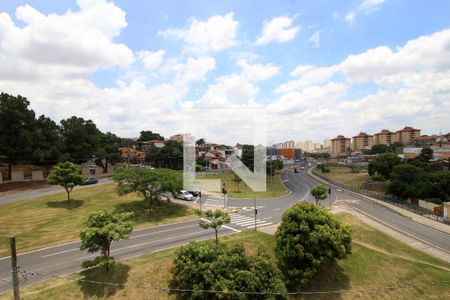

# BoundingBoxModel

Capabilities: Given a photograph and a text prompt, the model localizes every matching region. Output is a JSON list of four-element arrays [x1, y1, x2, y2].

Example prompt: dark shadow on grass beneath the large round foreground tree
[[290, 264, 350, 300]]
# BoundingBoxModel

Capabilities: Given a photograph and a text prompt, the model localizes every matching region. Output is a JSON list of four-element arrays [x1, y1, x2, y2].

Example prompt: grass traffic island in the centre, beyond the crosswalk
[[197, 172, 288, 198]]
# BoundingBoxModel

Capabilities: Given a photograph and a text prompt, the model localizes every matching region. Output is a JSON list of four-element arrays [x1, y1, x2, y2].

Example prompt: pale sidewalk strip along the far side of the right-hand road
[[306, 169, 450, 234]]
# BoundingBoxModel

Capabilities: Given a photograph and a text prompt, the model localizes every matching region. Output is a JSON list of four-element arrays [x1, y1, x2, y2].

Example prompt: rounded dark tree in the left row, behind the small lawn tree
[[61, 116, 102, 162]]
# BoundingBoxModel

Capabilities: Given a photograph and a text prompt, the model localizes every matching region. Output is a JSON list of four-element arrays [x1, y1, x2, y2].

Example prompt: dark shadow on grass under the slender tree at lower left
[[77, 262, 130, 298]]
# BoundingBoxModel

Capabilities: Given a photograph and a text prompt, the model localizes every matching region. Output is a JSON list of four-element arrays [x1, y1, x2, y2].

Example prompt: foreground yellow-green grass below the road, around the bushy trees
[[0, 214, 450, 300]]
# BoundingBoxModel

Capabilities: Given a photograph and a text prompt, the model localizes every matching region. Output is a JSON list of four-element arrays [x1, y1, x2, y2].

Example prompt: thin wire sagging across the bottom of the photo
[[17, 270, 450, 295]]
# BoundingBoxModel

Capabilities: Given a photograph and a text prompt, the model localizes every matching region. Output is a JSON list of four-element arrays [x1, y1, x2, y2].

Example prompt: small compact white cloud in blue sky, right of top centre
[[256, 16, 300, 45]]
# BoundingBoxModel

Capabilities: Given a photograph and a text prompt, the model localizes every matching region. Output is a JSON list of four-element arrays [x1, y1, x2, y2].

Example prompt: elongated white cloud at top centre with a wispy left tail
[[158, 12, 239, 52]]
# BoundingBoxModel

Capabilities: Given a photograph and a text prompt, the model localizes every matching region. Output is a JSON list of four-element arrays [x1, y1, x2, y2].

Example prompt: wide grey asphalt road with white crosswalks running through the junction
[[0, 170, 450, 292]]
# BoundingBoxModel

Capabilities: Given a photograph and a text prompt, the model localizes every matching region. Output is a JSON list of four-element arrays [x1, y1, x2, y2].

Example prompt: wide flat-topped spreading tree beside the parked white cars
[[113, 168, 183, 208]]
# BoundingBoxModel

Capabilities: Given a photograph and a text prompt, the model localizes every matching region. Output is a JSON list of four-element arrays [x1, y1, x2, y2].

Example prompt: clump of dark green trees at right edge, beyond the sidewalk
[[368, 148, 450, 203]]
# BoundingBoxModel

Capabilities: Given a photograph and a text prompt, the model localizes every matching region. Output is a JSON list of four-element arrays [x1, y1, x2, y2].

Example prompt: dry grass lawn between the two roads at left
[[0, 184, 194, 257]]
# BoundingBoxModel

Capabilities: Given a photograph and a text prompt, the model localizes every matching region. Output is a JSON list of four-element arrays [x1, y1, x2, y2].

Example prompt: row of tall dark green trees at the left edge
[[0, 93, 122, 178]]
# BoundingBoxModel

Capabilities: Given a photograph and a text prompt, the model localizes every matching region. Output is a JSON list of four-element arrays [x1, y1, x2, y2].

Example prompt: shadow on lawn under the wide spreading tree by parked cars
[[115, 200, 190, 223]]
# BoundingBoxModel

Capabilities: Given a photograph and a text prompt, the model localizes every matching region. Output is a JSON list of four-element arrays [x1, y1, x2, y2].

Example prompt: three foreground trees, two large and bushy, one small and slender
[[169, 201, 351, 299]]
